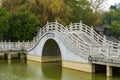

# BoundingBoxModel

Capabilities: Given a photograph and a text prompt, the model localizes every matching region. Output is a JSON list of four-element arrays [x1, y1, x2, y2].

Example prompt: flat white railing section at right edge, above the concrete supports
[[91, 46, 120, 63]]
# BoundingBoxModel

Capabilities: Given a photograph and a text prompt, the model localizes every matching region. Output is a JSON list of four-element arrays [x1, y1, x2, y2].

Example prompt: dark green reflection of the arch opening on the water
[[42, 62, 62, 80]]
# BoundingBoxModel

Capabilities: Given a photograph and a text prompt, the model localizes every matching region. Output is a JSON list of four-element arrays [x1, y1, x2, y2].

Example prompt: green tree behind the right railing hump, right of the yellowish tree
[[65, 0, 101, 26]]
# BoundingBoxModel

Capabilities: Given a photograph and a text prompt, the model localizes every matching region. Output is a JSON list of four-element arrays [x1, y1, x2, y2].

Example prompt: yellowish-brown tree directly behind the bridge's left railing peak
[[28, 0, 72, 26]]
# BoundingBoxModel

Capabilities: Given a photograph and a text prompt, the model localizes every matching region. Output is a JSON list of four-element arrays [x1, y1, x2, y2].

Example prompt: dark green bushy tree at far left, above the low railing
[[0, 6, 39, 41]]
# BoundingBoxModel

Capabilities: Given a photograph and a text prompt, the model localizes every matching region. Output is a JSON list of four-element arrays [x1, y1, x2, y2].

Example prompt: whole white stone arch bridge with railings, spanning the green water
[[0, 21, 120, 76]]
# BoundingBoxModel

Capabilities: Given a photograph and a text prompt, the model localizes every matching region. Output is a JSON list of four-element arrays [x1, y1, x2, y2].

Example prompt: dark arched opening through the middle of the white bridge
[[42, 39, 61, 62]]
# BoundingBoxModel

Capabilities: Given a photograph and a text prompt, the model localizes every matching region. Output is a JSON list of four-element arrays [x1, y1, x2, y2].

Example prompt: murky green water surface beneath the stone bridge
[[0, 60, 120, 80]]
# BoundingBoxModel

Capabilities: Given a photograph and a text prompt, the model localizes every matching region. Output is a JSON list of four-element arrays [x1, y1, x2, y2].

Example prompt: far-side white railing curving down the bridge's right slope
[[68, 22, 118, 45]]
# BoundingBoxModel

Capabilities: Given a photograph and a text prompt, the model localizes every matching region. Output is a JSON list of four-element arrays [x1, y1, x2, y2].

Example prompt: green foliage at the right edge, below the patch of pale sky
[[103, 6, 120, 39]]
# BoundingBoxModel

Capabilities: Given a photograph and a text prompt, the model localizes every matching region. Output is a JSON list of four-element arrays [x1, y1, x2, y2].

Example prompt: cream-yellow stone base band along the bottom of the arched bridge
[[27, 54, 95, 73]]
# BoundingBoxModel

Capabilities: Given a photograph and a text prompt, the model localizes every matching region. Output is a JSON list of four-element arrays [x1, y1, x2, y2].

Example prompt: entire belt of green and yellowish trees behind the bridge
[[0, 0, 120, 41]]
